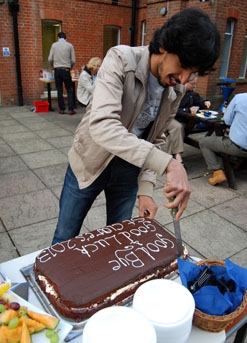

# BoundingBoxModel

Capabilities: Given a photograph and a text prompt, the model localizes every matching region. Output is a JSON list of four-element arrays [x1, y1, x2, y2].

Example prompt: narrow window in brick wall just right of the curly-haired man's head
[[220, 18, 235, 78]]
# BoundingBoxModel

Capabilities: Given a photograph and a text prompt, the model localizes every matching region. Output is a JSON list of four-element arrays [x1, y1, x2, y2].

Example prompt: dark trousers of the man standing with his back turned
[[54, 68, 75, 111]]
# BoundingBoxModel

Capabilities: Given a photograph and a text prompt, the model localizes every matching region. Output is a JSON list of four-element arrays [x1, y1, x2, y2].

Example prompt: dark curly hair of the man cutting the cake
[[149, 8, 220, 76]]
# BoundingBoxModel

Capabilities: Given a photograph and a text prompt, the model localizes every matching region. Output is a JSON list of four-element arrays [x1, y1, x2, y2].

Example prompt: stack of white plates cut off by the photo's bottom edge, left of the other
[[82, 306, 156, 343]]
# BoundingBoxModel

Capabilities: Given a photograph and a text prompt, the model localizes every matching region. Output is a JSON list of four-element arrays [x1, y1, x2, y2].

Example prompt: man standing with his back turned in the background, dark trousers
[[48, 32, 76, 115]]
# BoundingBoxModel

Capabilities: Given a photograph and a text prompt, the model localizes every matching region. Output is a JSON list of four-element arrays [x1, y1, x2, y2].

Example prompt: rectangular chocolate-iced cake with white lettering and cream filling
[[34, 217, 185, 322]]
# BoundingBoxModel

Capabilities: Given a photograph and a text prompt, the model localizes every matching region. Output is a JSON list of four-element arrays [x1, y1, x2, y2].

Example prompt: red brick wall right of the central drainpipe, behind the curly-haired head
[[137, 0, 247, 108]]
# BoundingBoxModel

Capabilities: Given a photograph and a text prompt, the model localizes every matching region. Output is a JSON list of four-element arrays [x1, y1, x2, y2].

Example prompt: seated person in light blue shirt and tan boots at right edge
[[199, 93, 247, 186]]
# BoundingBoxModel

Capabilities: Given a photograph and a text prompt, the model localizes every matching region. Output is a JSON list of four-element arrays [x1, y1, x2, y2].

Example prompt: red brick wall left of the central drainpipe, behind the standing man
[[0, 0, 131, 105]]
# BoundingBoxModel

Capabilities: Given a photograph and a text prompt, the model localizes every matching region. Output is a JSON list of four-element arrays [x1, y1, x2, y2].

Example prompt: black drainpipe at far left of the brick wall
[[8, 0, 23, 106]]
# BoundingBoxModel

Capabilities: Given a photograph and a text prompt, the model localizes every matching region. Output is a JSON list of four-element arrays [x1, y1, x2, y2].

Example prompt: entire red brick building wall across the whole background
[[0, 0, 247, 105]]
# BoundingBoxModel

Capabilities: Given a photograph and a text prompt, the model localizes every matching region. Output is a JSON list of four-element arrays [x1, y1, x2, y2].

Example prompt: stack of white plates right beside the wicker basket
[[133, 279, 195, 343]]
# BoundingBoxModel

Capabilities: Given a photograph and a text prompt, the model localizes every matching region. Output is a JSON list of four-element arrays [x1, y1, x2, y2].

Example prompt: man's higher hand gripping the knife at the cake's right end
[[163, 158, 191, 220]]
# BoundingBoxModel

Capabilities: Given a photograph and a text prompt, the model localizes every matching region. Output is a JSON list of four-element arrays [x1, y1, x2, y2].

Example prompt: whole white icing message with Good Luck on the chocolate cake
[[38, 218, 175, 271]]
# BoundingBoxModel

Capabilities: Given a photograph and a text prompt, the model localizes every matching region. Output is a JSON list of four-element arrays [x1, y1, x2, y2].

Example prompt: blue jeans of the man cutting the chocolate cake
[[52, 157, 140, 244]]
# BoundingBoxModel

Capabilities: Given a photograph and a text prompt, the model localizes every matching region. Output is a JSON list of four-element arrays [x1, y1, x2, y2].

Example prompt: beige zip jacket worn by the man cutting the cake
[[69, 45, 184, 196]]
